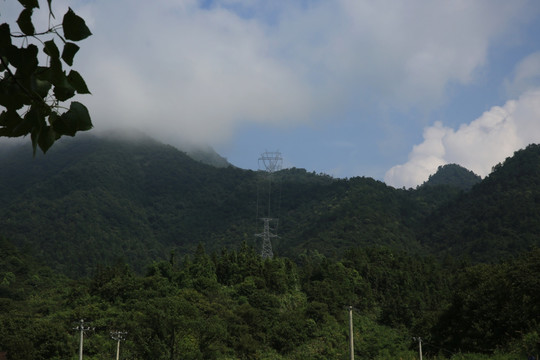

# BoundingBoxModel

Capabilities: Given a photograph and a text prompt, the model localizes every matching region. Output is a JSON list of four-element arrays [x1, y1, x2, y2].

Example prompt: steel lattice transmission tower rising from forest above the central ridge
[[255, 151, 283, 259]]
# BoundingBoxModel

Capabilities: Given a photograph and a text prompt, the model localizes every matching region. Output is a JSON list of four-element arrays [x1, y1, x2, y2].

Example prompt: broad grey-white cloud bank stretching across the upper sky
[[64, 0, 536, 148]]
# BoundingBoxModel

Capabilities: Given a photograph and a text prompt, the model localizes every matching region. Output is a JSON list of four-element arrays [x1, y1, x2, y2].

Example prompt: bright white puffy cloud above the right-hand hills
[[385, 89, 540, 187]]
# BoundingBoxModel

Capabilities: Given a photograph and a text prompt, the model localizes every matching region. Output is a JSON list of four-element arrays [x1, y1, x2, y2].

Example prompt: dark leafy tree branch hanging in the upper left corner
[[0, 0, 92, 155]]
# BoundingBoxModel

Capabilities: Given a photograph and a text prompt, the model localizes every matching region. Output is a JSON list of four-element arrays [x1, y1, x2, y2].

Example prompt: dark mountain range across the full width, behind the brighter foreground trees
[[0, 134, 540, 275]]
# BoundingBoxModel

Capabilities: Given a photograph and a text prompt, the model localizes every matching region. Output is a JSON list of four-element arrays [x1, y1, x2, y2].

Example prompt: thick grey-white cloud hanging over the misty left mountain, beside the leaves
[[79, 1, 314, 143]]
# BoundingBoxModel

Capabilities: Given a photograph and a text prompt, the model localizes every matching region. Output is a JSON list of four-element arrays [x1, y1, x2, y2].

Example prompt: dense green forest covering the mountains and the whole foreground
[[0, 135, 540, 359]]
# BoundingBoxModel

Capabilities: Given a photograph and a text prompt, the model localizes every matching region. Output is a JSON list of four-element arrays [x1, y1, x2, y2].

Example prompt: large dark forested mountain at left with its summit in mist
[[0, 135, 256, 273]]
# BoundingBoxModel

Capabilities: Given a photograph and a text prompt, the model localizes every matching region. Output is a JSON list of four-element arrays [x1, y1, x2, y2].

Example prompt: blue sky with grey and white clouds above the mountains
[[0, 0, 540, 188]]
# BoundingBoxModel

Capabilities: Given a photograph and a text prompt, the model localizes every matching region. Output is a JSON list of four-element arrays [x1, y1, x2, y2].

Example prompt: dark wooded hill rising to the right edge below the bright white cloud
[[419, 145, 540, 261]]
